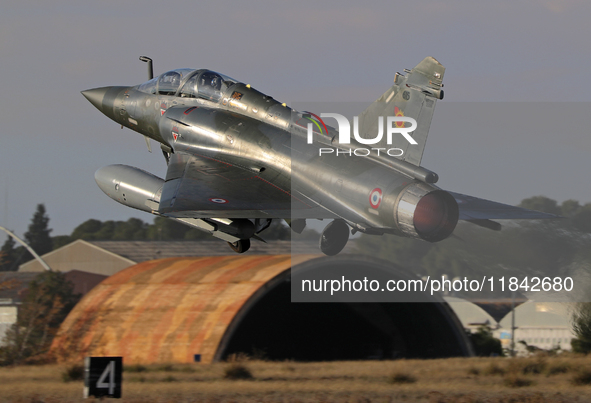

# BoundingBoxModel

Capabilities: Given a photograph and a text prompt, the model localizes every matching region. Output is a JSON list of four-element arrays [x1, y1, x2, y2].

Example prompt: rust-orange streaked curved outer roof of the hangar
[[52, 254, 315, 364]]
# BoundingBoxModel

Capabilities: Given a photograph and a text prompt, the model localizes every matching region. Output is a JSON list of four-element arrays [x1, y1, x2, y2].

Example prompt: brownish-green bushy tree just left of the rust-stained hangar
[[0, 271, 80, 365]]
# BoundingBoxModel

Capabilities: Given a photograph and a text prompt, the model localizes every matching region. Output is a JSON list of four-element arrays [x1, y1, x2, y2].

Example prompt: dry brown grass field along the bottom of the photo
[[0, 355, 591, 403]]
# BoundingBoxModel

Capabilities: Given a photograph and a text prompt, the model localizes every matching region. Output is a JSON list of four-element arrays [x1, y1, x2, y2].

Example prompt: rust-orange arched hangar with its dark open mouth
[[52, 255, 472, 364]]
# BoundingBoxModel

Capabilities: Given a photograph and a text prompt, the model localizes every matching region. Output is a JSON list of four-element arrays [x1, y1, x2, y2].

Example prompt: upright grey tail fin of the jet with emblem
[[359, 57, 445, 166]]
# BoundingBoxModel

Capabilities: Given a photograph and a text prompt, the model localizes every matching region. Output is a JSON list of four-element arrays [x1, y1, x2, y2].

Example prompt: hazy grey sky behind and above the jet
[[0, 0, 591, 242]]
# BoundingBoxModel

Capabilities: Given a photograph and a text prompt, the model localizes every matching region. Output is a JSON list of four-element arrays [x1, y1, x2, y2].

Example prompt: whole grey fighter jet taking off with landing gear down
[[82, 56, 556, 255]]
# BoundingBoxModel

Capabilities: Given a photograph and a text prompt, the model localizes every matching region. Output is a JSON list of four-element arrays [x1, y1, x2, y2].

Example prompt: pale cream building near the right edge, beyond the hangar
[[495, 301, 575, 354]]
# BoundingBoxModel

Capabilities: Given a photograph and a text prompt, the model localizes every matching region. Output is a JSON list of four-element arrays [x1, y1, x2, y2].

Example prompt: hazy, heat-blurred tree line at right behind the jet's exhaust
[[355, 196, 591, 286]]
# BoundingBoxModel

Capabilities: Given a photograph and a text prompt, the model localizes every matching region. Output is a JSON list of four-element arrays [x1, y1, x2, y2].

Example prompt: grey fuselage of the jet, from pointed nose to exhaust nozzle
[[83, 69, 458, 241]]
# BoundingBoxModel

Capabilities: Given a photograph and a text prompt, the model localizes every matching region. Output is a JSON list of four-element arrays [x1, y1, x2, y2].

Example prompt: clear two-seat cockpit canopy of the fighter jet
[[138, 69, 238, 102]]
